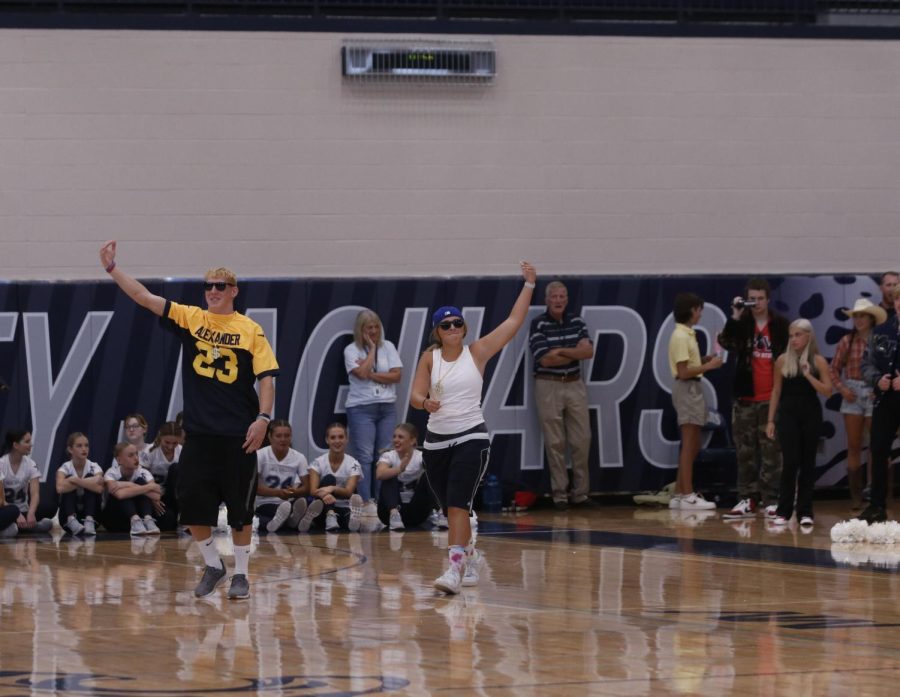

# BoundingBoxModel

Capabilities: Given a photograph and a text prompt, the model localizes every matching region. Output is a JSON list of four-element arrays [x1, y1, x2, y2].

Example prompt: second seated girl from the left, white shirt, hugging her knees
[[56, 431, 103, 535]]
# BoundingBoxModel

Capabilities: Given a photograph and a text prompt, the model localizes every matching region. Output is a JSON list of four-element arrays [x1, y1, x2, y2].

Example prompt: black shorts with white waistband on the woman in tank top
[[422, 425, 491, 512]]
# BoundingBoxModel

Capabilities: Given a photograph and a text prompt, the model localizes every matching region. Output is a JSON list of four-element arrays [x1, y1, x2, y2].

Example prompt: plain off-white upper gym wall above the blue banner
[[0, 30, 900, 279]]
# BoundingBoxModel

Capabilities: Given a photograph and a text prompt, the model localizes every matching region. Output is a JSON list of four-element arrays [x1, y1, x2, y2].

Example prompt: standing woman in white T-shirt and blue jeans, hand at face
[[344, 310, 403, 502]]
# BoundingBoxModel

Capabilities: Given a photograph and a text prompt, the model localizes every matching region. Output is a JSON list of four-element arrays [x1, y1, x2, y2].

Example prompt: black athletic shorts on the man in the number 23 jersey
[[176, 434, 258, 530]]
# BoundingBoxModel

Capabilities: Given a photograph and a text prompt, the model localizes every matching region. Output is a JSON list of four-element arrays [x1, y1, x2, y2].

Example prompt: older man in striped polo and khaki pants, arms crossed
[[529, 281, 596, 511]]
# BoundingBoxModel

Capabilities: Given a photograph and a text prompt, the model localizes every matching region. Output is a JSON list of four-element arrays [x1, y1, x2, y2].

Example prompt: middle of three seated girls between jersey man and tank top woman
[[309, 423, 363, 532]]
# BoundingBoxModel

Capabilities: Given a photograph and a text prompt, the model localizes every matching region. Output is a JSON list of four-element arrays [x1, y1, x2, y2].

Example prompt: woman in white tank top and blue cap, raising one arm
[[410, 261, 537, 593]]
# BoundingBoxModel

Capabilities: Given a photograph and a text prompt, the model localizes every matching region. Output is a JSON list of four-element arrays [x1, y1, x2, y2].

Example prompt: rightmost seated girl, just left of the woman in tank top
[[375, 423, 435, 530]]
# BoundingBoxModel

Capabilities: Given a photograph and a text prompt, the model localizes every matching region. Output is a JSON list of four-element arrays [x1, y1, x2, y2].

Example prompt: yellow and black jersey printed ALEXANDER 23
[[161, 300, 278, 436]]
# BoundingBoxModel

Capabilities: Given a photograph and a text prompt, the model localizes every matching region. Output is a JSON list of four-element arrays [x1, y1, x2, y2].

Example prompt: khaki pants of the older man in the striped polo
[[534, 379, 591, 503]]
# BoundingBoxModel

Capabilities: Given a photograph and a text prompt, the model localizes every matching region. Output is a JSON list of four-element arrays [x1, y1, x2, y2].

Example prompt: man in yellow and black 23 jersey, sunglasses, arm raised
[[100, 241, 278, 600]]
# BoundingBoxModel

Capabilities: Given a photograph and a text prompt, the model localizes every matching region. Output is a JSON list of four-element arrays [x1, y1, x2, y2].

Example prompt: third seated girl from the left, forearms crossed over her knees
[[102, 442, 162, 536]]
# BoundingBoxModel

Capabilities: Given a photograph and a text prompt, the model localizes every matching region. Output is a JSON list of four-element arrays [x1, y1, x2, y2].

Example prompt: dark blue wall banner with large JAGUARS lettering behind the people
[[0, 276, 880, 506]]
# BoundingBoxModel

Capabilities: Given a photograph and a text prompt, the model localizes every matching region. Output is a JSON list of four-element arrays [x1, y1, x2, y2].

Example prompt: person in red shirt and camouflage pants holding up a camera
[[719, 278, 788, 520]]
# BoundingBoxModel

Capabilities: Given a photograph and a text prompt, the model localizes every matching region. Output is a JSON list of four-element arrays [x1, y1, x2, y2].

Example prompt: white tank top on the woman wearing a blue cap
[[428, 346, 484, 435]]
